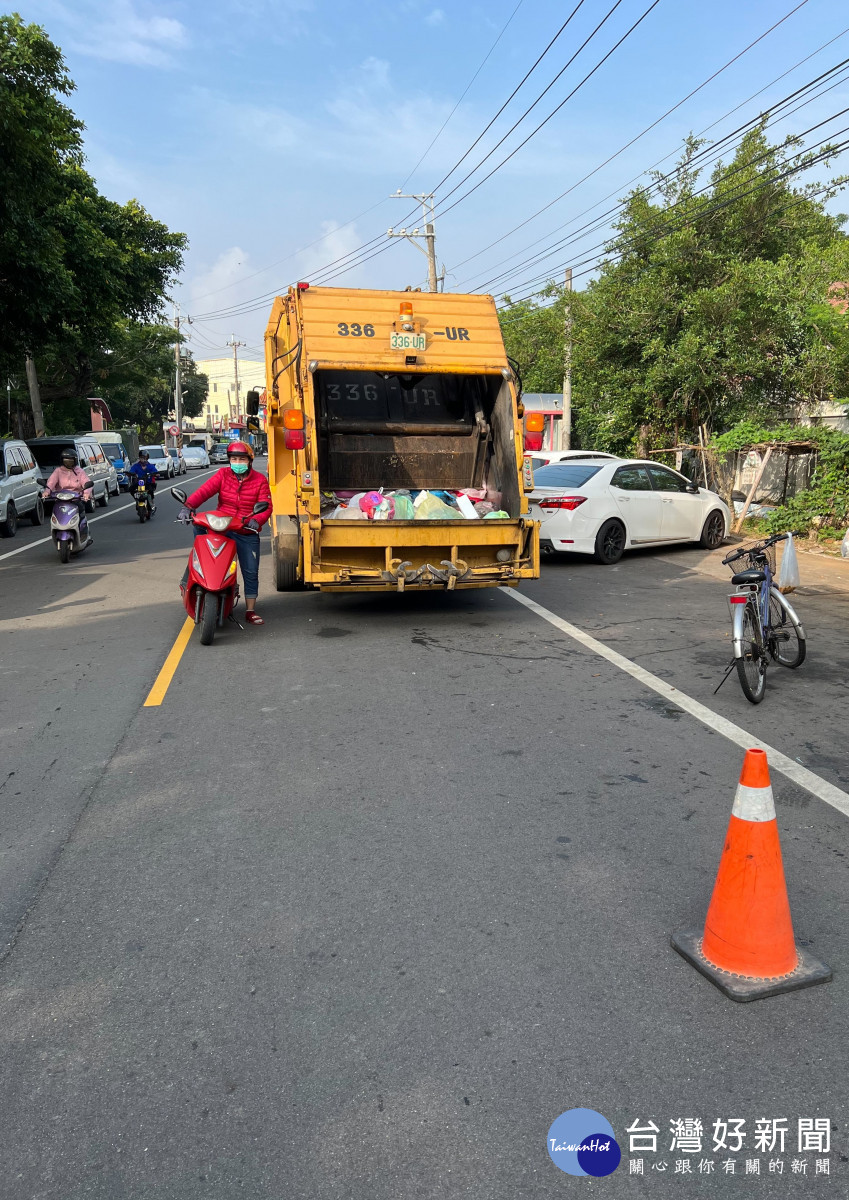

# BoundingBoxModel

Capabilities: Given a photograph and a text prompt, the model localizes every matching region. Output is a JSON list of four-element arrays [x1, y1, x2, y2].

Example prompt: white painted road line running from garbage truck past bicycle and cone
[[508, 588, 849, 817]]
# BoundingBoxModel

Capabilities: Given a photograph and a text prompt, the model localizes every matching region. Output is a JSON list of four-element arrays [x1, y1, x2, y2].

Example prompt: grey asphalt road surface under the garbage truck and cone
[[0, 489, 849, 1200]]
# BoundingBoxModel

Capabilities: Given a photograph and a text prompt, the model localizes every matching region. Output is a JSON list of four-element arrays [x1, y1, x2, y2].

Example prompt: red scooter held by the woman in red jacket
[[170, 487, 269, 646]]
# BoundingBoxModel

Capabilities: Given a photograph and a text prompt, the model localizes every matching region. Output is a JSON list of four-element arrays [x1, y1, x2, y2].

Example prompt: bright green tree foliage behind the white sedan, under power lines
[[504, 128, 849, 452]]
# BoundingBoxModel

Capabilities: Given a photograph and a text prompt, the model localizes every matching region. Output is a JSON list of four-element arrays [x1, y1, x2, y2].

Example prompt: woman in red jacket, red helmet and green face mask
[[177, 442, 271, 625]]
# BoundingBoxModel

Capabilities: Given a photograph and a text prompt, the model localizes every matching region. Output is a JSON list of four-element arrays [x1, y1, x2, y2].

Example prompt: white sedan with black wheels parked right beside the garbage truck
[[528, 458, 730, 564]]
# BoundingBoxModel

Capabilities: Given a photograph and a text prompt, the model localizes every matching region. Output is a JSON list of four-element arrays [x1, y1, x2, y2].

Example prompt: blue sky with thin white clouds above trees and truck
[[16, 0, 849, 358]]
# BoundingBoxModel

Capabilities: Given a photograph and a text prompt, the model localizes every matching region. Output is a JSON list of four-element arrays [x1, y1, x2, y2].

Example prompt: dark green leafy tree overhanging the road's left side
[[0, 14, 186, 426]]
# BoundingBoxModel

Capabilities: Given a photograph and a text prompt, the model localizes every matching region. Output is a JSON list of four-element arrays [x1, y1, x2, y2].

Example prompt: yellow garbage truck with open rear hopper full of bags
[[253, 283, 540, 592]]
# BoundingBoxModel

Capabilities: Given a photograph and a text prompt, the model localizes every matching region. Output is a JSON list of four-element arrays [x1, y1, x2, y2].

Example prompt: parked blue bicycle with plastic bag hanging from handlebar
[[722, 533, 806, 704]]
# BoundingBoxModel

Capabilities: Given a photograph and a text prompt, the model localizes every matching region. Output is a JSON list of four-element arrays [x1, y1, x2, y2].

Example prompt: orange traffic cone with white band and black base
[[672, 750, 831, 1001]]
